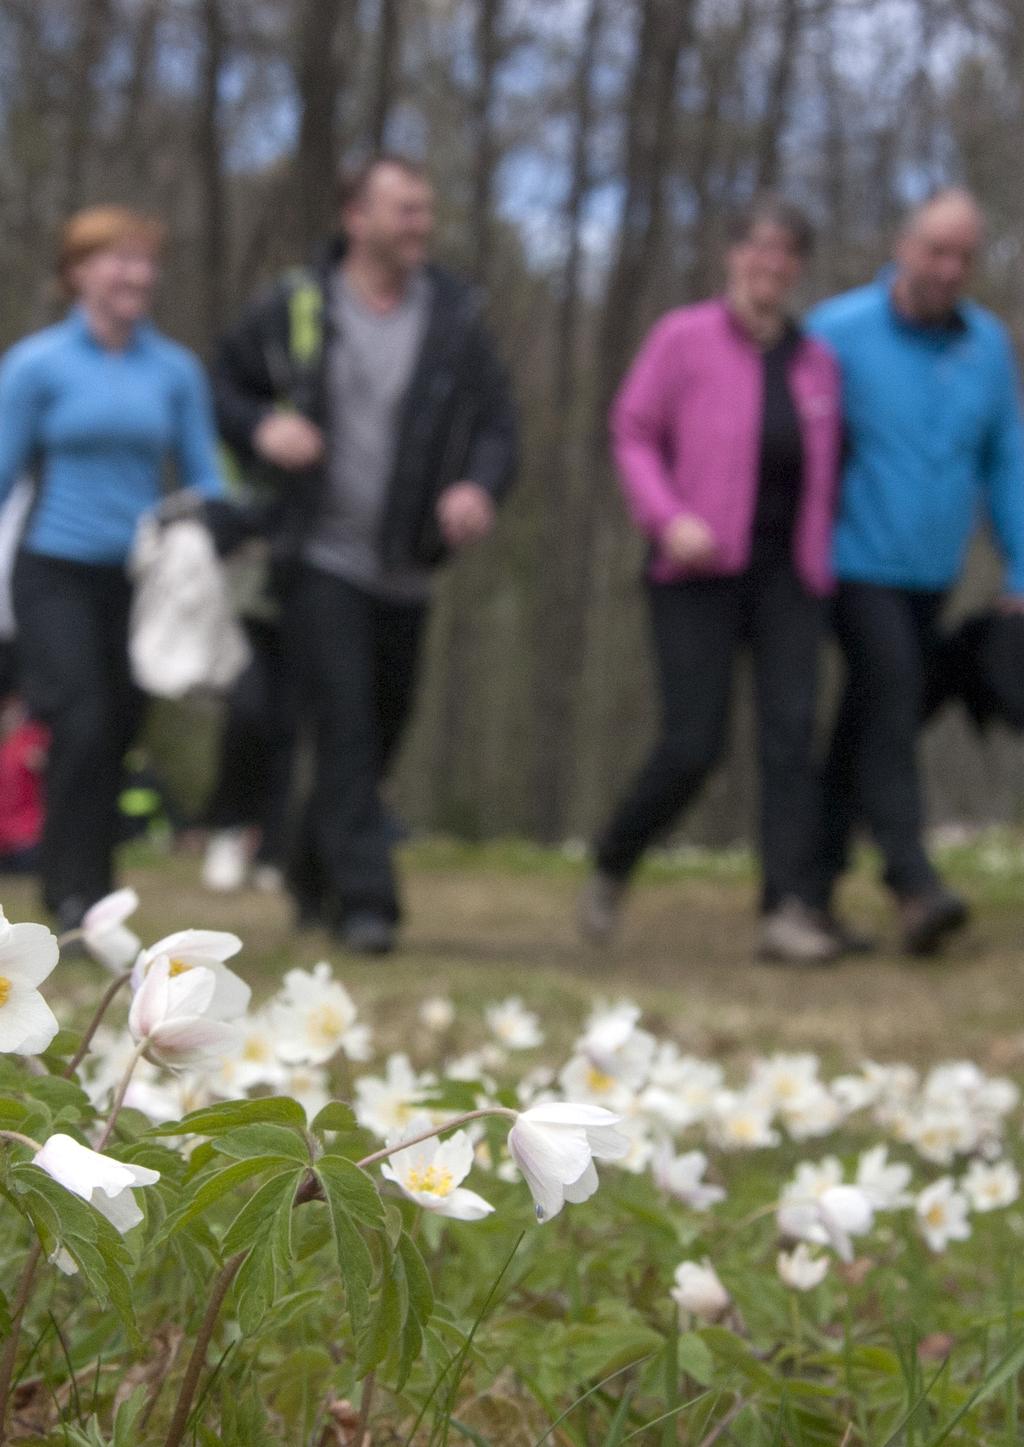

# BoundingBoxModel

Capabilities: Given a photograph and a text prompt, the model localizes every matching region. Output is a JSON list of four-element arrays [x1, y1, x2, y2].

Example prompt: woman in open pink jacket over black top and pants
[[581, 197, 840, 962]]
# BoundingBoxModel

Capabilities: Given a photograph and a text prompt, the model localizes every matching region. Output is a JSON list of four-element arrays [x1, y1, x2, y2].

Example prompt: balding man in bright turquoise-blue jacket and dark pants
[[808, 191, 1024, 954]]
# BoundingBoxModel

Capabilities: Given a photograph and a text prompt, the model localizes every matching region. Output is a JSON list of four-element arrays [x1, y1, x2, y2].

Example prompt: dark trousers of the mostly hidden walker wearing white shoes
[[207, 619, 298, 865]]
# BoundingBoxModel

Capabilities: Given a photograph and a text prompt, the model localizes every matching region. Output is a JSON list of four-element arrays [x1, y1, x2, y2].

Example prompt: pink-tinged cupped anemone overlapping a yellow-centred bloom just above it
[[129, 955, 240, 1066]]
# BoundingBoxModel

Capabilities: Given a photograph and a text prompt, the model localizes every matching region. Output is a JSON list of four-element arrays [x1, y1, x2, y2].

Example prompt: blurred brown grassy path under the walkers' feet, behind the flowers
[[3, 835, 1024, 1074]]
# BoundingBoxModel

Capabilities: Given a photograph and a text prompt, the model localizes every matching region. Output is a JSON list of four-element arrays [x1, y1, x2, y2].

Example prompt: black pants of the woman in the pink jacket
[[596, 559, 823, 909]]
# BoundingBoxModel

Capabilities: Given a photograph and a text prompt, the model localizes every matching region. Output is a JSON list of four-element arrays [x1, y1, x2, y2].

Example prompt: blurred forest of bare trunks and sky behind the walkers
[[0, 0, 1024, 844]]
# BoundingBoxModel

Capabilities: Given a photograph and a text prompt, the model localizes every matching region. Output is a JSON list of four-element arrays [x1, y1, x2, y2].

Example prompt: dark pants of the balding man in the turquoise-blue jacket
[[817, 583, 946, 904]]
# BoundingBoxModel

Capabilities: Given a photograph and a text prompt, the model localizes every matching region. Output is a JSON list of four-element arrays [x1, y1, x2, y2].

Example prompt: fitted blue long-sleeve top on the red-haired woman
[[0, 308, 223, 564]]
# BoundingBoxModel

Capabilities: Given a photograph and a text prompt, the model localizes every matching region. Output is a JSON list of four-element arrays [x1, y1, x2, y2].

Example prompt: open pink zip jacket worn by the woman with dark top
[[610, 298, 842, 595]]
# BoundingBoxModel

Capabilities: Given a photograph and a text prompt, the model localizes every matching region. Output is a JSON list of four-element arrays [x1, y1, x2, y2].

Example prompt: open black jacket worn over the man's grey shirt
[[213, 240, 518, 569]]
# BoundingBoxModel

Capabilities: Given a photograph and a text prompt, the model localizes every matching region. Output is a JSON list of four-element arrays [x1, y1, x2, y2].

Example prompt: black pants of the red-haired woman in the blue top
[[13, 553, 142, 910]]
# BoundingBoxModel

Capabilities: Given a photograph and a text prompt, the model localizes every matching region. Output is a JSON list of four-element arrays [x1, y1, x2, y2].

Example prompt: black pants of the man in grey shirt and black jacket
[[285, 564, 427, 925]]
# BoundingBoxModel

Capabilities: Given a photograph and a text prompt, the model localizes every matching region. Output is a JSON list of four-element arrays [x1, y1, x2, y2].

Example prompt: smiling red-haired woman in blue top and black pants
[[0, 207, 221, 929]]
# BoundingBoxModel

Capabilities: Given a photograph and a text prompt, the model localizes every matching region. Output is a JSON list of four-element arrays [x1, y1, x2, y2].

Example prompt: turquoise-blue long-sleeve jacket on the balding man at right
[[807, 273, 1024, 595]]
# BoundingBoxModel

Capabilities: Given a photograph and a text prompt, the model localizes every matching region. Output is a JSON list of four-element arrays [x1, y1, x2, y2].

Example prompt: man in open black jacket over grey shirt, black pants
[[214, 156, 516, 954]]
